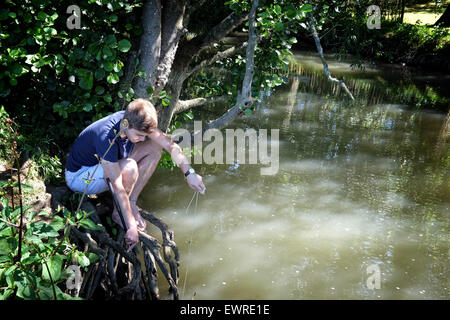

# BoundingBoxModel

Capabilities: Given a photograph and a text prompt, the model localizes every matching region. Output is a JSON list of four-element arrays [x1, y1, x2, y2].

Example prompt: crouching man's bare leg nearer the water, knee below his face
[[130, 141, 162, 229]]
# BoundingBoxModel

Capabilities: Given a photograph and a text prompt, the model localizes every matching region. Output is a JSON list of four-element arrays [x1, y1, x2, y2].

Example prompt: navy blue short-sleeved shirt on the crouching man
[[66, 111, 134, 172]]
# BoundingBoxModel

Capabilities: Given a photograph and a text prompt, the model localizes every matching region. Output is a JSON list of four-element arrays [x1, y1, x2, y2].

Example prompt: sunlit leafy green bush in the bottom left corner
[[0, 198, 102, 300]]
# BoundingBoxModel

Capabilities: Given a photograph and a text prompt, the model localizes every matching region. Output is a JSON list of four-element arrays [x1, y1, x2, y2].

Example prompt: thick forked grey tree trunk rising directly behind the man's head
[[133, 0, 248, 131]]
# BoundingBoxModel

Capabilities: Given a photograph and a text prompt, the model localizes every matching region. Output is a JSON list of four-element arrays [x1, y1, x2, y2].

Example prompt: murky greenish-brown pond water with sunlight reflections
[[138, 53, 450, 300]]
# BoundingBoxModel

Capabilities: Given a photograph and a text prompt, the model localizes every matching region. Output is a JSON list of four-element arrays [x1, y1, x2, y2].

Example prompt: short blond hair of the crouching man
[[123, 98, 158, 133]]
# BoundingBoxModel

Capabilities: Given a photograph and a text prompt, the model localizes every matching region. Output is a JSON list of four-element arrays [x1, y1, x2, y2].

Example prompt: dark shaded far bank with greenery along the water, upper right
[[293, 21, 450, 73]]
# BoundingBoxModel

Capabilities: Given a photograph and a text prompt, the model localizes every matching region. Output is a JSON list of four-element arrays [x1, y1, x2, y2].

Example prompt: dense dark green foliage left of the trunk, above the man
[[0, 1, 141, 139]]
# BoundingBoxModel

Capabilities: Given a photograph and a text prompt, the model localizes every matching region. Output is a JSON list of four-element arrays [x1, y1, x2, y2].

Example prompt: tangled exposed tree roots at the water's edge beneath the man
[[52, 188, 180, 300]]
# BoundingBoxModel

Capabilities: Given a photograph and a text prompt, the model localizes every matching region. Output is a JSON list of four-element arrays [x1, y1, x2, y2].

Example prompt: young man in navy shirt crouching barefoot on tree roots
[[65, 99, 205, 250]]
